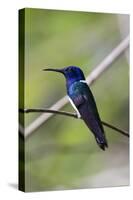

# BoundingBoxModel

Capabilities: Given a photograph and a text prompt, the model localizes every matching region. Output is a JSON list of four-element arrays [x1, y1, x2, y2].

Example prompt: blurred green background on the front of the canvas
[[20, 9, 129, 191]]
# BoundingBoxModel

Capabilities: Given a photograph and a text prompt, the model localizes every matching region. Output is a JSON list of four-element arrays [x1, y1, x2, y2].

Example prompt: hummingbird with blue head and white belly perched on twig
[[43, 66, 108, 150]]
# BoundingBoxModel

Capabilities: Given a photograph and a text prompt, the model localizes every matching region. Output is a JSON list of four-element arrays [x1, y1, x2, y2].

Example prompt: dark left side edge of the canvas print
[[18, 9, 25, 191]]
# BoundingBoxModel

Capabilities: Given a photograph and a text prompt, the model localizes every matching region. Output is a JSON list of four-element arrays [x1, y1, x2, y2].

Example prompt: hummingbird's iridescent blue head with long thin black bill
[[44, 66, 85, 85]]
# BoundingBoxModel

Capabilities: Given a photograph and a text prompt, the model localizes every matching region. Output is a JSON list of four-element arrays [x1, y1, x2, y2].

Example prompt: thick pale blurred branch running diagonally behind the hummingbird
[[21, 36, 129, 137]]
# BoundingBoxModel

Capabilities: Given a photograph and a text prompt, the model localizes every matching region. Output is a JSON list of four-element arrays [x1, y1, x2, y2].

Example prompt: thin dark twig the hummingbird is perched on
[[19, 108, 129, 137]]
